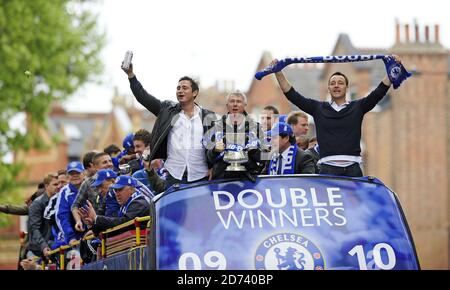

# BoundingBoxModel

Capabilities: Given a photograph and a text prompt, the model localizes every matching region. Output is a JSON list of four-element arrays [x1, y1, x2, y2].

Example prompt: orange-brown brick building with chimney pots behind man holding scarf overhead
[[248, 23, 450, 269]]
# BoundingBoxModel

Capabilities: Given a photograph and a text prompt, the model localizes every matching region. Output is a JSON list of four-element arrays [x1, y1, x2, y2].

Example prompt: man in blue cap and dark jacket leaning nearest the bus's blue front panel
[[79, 175, 150, 233]]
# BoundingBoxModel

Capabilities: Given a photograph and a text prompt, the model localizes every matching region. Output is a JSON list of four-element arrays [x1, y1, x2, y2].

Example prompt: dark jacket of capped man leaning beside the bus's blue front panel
[[92, 195, 150, 233]]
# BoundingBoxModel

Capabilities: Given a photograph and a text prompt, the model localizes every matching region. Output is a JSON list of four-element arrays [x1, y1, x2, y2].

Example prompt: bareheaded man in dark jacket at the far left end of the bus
[[28, 173, 58, 257]]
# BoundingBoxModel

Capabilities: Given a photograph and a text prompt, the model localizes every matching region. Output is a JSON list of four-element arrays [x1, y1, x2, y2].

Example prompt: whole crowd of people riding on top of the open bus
[[0, 56, 400, 270]]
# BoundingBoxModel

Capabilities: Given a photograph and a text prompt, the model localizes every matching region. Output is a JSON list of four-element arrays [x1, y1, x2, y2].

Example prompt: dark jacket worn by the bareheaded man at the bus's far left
[[28, 193, 51, 254]]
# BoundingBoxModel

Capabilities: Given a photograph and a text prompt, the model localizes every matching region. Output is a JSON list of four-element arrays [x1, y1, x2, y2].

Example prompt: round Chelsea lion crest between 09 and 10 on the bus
[[255, 233, 325, 270]]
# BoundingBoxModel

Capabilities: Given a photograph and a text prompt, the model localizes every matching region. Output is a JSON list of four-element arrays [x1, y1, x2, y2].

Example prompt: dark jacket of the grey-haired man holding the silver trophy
[[204, 113, 265, 179]]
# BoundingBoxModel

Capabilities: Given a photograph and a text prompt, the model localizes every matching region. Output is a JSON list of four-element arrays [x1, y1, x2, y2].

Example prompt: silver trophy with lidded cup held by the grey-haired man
[[223, 133, 248, 171]]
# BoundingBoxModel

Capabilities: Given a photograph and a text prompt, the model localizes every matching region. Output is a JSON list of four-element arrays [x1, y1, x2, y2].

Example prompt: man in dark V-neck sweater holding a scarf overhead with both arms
[[271, 55, 401, 177]]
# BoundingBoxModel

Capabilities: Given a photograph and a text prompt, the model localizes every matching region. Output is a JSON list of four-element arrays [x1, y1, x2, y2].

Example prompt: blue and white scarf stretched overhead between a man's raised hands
[[255, 54, 411, 89]]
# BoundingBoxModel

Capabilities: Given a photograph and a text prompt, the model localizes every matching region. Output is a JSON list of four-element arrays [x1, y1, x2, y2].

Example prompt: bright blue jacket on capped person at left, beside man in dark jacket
[[56, 183, 83, 244]]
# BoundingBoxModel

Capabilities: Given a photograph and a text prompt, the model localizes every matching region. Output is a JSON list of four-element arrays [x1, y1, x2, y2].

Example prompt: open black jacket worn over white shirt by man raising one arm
[[129, 77, 217, 163]]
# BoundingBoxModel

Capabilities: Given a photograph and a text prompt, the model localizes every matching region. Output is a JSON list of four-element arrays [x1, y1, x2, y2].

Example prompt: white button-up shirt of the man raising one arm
[[164, 105, 208, 182]]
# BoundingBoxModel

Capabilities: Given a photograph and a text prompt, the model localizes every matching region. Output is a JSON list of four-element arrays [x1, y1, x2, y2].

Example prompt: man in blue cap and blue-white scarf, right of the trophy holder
[[265, 122, 314, 175]]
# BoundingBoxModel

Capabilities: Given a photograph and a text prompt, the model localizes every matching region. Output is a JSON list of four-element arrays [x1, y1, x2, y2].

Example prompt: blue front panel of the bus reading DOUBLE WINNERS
[[156, 176, 419, 270]]
